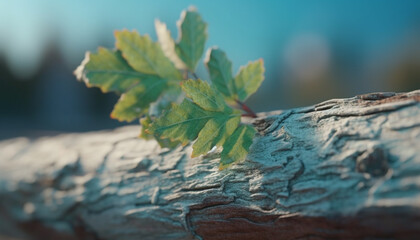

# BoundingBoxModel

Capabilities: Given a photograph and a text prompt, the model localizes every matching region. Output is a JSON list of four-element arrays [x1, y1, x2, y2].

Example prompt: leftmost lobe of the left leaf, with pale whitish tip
[[74, 48, 146, 92]]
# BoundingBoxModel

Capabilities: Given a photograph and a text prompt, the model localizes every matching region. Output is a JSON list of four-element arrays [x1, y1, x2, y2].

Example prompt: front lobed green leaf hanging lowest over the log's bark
[[150, 80, 255, 166]]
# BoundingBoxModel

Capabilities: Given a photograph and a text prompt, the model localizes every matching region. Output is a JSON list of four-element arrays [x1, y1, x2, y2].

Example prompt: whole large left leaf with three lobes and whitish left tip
[[75, 30, 185, 121]]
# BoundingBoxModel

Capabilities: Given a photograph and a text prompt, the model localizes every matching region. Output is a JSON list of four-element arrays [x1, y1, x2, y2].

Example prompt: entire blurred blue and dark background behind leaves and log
[[0, 0, 420, 139]]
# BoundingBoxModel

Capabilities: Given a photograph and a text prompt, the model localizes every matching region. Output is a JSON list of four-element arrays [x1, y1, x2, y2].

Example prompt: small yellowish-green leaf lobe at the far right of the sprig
[[235, 59, 264, 101]]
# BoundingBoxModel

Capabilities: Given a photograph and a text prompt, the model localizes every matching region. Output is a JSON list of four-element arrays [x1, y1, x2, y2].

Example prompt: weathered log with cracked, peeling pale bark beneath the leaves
[[0, 91, 420, 239]]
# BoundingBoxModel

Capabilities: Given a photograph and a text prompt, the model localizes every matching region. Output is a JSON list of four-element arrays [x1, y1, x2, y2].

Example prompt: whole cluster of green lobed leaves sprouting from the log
[[75, 8, 264, 169]]
